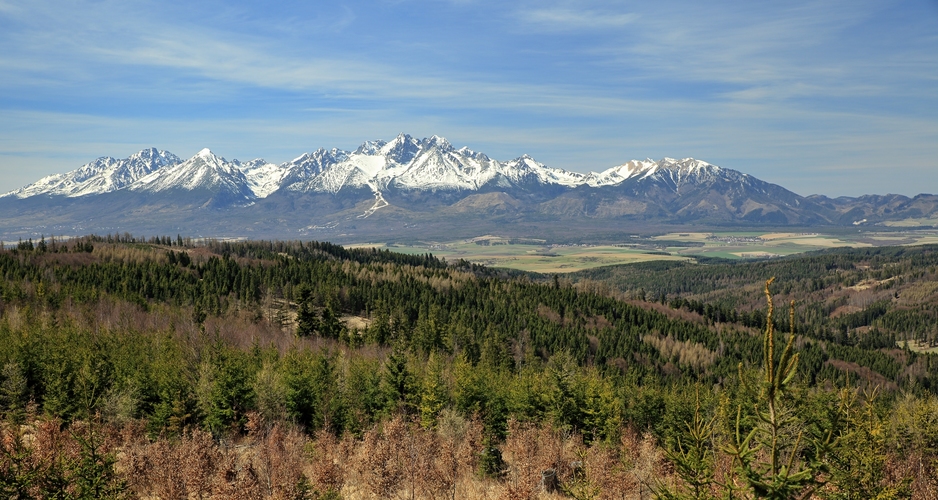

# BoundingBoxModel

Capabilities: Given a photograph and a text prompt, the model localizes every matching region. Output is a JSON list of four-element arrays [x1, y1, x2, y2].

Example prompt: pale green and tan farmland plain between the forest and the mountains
[[348, 230, 938, 273]]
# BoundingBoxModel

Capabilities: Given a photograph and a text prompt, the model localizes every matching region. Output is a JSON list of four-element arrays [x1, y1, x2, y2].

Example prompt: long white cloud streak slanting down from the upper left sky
[[0, 10, 696, 116]]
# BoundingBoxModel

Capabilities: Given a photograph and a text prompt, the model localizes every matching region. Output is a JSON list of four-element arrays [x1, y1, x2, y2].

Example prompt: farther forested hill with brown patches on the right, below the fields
[[570, 245, 938, 349]]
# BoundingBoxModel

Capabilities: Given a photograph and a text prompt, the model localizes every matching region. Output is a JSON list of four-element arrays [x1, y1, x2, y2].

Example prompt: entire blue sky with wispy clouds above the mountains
[[0, 0, 938, 196]]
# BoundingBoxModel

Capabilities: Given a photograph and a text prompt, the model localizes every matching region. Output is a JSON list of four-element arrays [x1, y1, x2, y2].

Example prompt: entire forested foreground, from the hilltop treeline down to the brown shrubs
[[0, 234, 938, 499]]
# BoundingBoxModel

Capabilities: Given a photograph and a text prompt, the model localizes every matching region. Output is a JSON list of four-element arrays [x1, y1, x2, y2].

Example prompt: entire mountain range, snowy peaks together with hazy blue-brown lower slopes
[[0, 134, 938, 241]]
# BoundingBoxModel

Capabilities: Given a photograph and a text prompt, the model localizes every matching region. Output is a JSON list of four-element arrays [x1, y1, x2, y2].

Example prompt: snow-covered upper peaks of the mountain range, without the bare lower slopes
[[2, 134, 748, 202]]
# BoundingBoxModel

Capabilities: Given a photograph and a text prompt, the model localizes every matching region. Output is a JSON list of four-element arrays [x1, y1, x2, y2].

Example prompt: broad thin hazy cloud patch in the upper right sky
[[572, 1, 938, 100]]
